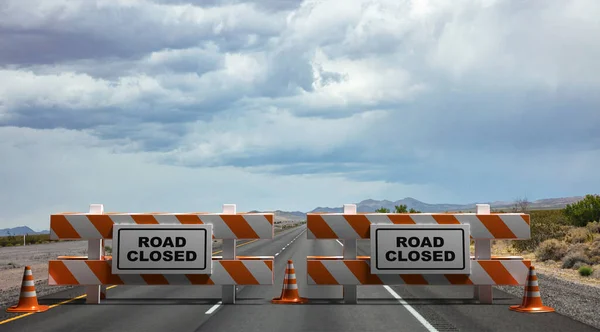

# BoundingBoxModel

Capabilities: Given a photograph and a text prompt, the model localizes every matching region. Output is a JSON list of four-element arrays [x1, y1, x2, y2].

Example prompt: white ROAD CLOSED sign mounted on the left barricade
[[112, 224, 212, 274]]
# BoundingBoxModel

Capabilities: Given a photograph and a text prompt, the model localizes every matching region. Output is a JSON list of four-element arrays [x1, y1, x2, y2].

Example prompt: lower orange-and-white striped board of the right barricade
[[307, 256, 531, 286]]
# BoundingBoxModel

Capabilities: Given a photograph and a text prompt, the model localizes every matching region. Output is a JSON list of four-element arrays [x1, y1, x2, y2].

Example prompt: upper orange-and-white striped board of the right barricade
[[306, 213, 531, 240]]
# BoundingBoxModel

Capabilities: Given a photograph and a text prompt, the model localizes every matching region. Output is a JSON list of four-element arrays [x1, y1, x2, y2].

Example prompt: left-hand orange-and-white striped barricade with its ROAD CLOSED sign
[[48, 204, 274, 303]]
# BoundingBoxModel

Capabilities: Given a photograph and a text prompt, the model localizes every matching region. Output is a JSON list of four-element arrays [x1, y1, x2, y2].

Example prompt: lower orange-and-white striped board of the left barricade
[[48, 256, 274, 285]]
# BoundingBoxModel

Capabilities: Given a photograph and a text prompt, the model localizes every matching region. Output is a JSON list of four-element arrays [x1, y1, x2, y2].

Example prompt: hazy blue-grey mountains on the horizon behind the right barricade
[[252, 196, 583, 221]]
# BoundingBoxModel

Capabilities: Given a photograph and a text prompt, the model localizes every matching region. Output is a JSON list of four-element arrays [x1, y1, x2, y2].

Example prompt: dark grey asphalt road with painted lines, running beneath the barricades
[[0, 226, 598, 332]]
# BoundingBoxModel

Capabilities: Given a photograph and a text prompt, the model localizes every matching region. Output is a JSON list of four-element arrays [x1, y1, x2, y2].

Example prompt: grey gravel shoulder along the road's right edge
[[497, 273, 600, 329]]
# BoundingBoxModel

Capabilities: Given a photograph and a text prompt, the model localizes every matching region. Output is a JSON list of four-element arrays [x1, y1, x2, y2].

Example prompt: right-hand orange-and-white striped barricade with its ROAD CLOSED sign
[[307, 204, 531, 303]]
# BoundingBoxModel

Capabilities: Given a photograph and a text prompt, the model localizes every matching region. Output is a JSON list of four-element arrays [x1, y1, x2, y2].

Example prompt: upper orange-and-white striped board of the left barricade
[[50, 213, 275, 240]]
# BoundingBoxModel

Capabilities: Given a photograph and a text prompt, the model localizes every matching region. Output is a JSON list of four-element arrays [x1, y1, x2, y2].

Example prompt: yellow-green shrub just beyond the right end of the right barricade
[[512, 210, 569, 252]]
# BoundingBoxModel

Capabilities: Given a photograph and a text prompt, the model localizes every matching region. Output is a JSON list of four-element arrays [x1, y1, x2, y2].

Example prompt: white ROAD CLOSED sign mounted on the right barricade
[[371, 224, 471, 274]]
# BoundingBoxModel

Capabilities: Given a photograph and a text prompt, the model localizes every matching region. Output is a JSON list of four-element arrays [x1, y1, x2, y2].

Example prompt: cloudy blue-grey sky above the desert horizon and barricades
[[0, 0, 600, 229]]
